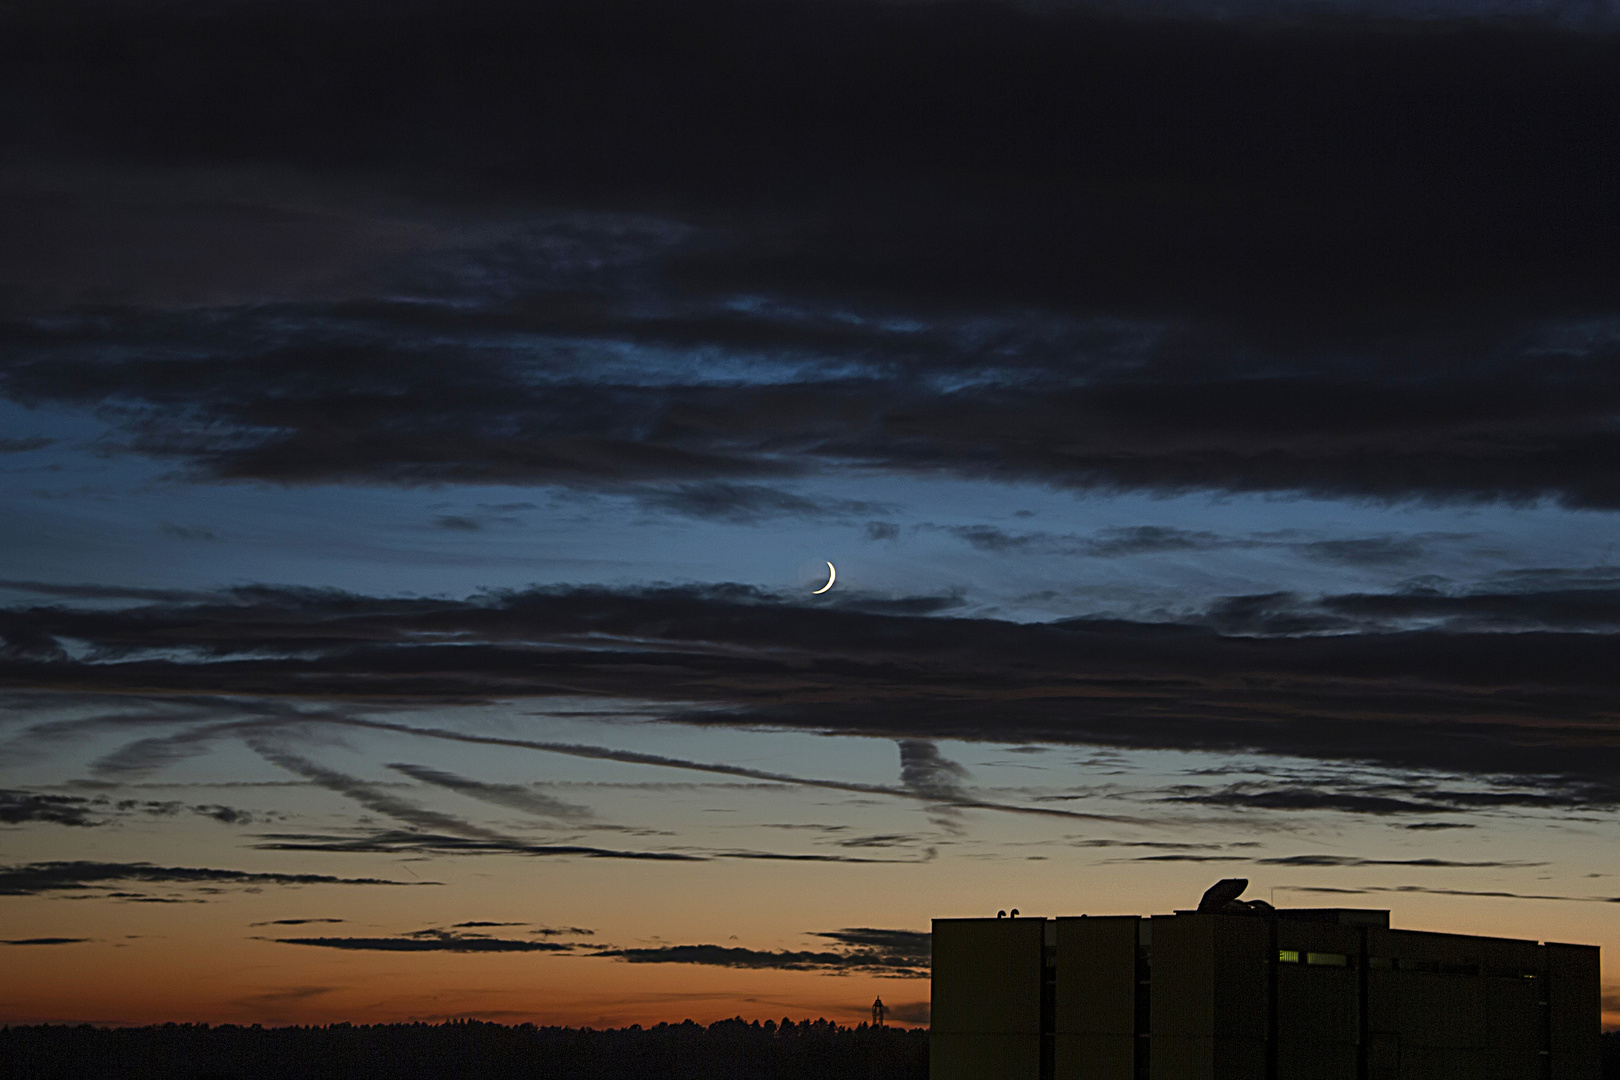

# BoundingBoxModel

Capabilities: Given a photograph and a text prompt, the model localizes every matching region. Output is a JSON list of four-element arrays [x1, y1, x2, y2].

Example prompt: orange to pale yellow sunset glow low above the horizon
[[0, 709, 1620, 1028]]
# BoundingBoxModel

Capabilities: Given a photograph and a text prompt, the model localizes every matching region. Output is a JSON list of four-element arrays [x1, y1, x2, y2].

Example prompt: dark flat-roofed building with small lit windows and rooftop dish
[[930, 879, 1601, 1080]]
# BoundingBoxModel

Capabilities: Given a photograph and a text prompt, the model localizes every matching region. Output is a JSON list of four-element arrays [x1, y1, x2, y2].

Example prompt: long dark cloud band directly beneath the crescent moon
[[9, 586, 1620, 803]]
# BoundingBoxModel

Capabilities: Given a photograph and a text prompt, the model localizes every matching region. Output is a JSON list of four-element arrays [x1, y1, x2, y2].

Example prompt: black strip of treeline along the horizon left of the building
[[0, 1020, 928, 1080]]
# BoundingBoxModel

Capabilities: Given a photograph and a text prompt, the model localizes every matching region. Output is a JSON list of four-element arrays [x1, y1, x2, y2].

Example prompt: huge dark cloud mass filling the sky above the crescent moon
[[0, 0, 1620, 511]]
